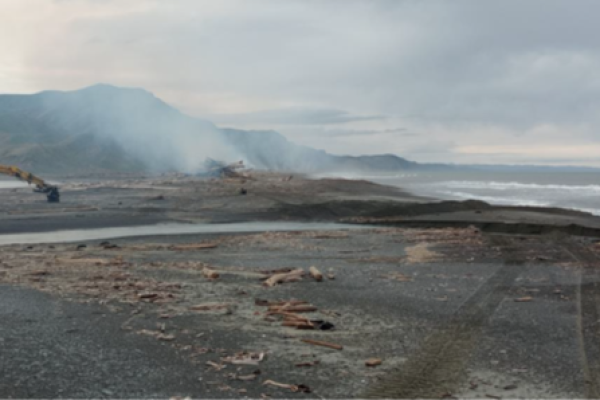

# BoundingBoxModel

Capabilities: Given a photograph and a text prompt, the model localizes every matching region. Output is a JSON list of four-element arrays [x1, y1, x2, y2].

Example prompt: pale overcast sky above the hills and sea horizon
[[0, 0, 600, 165]]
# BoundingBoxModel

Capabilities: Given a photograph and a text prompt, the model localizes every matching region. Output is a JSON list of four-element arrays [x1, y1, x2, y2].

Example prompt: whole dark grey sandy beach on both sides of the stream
[[0, 174, 600, 400]]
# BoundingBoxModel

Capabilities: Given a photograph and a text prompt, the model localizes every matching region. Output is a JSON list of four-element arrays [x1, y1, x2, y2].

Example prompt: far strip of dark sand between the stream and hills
[[0, 173, 600, 236]]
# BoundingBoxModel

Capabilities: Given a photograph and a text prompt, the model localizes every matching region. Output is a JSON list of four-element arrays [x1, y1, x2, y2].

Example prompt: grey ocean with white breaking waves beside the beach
[[363, 171, 600, 215]]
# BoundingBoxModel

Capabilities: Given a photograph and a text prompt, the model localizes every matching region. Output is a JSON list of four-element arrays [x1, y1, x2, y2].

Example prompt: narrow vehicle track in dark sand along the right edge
[[564, 243, 600, 400]]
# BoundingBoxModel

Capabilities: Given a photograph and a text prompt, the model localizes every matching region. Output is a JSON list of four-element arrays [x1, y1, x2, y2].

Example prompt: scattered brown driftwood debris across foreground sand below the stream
[[0, 227, 408, 399]]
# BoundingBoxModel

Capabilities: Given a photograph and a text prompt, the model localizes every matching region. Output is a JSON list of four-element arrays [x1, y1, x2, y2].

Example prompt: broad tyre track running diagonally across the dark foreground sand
[[359, 236, 523, 400]]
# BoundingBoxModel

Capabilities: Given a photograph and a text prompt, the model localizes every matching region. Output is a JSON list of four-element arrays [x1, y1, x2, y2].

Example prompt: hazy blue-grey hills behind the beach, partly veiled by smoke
[[0, 85, 417, 173]]
